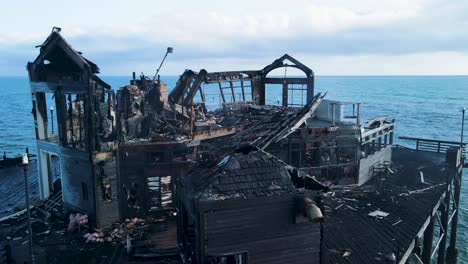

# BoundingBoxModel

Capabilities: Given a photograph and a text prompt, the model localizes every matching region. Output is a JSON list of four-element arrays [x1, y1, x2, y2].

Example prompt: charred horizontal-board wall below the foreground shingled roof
[[204, 196, 320, 263]]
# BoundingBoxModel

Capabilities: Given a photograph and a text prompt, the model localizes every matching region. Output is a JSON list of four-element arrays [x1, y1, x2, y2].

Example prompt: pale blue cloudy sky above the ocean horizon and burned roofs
[[0, 0, 468, 76]]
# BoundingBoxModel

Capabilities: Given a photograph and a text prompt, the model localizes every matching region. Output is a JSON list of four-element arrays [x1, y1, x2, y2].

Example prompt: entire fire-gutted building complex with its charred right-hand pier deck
[[27, 28, 465, 263]]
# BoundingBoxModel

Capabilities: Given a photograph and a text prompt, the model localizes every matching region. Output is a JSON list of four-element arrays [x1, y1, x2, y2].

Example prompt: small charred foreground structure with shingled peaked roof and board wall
[[178, 146, 322, 264]]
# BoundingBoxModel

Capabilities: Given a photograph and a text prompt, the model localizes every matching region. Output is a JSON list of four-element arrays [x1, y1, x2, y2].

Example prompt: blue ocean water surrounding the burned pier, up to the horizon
[[0, 76, 468, 263]]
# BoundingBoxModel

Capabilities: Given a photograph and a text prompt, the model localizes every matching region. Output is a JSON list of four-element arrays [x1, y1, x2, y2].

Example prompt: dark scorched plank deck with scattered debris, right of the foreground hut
[[323, 147, 449, 264]]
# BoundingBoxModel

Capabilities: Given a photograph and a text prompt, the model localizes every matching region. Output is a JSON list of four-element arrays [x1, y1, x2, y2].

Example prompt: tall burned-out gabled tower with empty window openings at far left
[[27, 28, 120, 226]]
